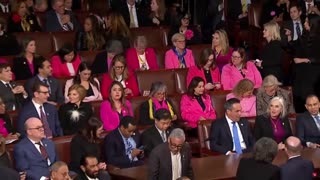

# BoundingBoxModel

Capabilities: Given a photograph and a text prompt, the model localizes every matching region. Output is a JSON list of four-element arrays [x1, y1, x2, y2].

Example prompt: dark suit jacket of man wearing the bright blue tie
[[210, 117, 255, 154]]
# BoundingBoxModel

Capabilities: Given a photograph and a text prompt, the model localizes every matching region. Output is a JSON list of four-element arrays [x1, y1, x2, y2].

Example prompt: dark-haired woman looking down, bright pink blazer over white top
[[51, 44, 81, 77]]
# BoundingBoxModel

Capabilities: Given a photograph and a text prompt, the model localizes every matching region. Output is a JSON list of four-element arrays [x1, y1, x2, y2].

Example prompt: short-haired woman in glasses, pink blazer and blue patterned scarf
[[165, 33, 195, 69]]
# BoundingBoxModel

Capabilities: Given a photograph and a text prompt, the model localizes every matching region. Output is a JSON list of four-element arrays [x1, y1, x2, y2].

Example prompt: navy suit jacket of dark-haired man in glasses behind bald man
[[17, 101, 63, 137]]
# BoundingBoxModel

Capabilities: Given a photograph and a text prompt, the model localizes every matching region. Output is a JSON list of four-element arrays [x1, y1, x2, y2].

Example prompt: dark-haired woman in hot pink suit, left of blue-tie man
[[180, 76, 217, 136]]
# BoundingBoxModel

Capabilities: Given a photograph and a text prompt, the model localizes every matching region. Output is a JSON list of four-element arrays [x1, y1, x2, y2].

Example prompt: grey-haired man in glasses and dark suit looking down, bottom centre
[[148, 128, 193, 180]]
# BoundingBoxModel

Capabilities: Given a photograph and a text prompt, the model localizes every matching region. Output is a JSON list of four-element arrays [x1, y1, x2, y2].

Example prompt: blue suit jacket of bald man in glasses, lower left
[[14, 138, 57, 180]]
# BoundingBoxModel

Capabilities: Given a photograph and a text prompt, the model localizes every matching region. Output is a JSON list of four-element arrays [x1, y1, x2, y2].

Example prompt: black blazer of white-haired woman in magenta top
[[253, 114, 292, 142]]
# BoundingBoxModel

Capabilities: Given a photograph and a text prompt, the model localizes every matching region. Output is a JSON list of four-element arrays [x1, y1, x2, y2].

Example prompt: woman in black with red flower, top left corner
[[8, 0, 41, 32]]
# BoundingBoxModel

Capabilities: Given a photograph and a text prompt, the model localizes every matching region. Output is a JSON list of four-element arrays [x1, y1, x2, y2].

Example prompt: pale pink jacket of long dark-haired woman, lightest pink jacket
[[64, 78, 102, 103]]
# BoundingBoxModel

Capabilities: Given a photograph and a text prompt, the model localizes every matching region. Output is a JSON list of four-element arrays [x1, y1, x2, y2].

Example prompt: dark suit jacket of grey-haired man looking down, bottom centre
[[148, 142, 194, 180]]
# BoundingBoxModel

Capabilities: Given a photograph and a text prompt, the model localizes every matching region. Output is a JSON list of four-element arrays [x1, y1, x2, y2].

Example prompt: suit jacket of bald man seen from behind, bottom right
[[281, 156, 314, 180]]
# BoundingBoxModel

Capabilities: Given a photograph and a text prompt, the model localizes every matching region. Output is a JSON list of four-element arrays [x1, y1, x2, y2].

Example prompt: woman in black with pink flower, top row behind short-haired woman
[[168, 11, 201, 45]]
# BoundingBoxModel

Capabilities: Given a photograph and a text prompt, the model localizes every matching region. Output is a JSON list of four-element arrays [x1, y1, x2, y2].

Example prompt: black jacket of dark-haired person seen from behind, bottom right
[[236, 158, 281, 180]]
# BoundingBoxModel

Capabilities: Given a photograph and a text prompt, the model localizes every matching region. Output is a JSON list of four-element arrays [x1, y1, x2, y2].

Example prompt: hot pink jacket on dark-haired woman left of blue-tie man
[[180, 94, 217, 128]]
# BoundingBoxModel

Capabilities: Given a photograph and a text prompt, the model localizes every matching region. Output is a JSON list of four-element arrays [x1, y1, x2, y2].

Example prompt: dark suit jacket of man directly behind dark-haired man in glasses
[[24, 75, 64, 104]]
